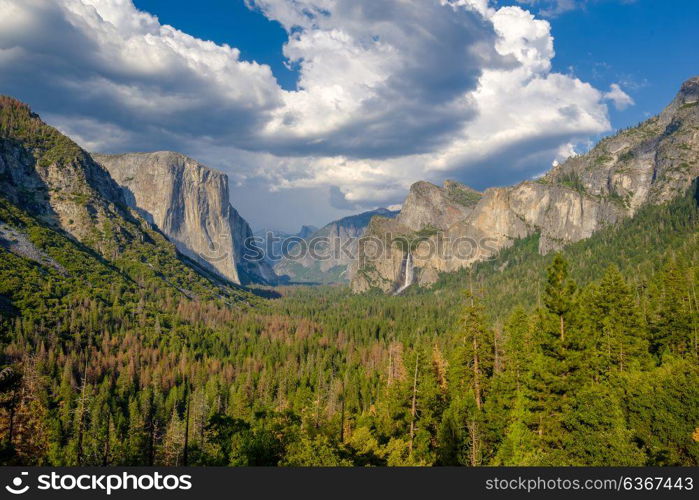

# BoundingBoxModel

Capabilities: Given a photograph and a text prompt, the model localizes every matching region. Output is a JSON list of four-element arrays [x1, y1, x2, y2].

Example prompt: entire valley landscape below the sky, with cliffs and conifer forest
[[0, 78, 699, 466]]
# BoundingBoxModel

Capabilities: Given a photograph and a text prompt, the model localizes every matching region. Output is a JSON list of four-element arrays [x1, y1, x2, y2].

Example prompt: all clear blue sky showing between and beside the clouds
[[134, 0, 699, 136]]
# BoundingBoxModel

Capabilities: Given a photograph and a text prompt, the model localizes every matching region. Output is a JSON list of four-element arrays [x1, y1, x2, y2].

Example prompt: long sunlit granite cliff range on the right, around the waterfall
[[352, 77, 699, 293]]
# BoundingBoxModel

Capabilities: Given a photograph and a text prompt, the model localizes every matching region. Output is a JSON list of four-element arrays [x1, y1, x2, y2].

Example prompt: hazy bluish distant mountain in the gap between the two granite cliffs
[[274, 208, 398, 283]]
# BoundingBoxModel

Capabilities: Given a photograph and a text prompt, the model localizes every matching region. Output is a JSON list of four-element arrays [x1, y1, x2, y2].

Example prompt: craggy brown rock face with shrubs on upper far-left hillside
[[0, 97, 148, 259]]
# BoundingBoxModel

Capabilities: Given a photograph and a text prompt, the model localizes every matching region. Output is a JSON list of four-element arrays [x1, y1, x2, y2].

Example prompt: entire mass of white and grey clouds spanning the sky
[[0, 0, 633, 228]]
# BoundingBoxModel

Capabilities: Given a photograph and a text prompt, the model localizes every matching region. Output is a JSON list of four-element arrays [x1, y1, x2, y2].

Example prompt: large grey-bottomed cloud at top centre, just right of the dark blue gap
[[248, 0, 514, 158]]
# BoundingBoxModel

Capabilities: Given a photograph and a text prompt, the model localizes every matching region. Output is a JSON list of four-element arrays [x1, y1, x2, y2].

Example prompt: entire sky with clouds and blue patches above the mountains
[[0, 0, 699, 231]]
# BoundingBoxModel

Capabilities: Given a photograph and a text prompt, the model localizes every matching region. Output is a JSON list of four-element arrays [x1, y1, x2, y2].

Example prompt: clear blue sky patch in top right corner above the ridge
[[524, 0, 699, 128]]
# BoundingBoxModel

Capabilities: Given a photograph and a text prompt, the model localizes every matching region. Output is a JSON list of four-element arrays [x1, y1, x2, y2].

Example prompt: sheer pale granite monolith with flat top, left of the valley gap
[[92, 151, 276, 284]]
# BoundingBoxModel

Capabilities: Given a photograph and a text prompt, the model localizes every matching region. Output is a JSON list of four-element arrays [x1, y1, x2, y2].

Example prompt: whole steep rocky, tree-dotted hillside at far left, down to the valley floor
[[0, 96, 251, 301]]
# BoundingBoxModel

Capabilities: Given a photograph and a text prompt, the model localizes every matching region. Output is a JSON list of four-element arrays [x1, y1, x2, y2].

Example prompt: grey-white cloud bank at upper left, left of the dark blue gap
[[0, 0, 282, 148]]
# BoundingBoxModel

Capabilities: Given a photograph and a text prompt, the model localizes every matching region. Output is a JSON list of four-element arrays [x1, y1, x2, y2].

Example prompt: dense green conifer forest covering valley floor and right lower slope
[[0, 180, 699, 465]]
